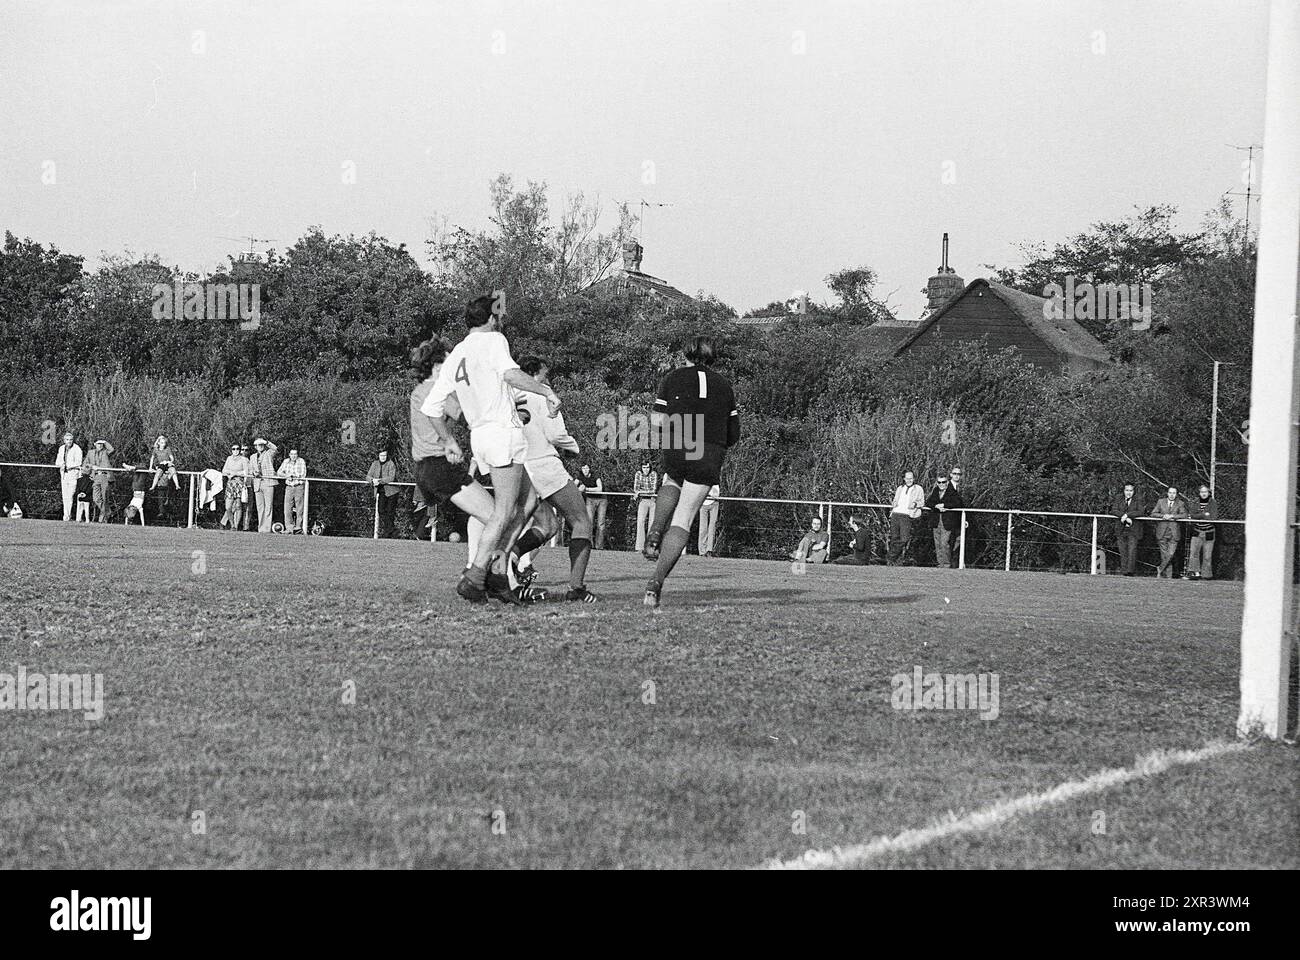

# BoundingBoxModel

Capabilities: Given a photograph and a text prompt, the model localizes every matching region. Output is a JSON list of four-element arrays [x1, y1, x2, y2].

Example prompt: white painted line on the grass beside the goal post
[[763, 740, 1249, 870]]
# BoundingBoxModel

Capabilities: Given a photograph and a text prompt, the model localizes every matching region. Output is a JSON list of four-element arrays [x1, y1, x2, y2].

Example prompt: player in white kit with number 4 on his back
[[420, 297, 560, 604]]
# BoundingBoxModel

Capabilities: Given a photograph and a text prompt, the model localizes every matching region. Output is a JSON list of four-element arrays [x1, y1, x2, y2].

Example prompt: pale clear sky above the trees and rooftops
[[0, 0, 1268, 317]]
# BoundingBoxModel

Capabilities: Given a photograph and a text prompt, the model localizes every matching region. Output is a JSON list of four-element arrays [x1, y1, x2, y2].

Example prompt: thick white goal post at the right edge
[[1236, 0, 1300, 738]]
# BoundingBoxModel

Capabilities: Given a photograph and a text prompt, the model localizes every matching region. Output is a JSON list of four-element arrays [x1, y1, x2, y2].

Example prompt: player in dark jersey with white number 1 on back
[[644, 337, 740, 606]]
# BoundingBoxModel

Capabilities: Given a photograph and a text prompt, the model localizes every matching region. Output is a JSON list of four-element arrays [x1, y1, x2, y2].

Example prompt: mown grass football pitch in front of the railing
[[0, 520, 1300, 868]]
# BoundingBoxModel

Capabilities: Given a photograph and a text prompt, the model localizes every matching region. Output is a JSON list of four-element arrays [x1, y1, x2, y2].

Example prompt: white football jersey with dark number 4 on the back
[[420, 330, 523, 431]]
